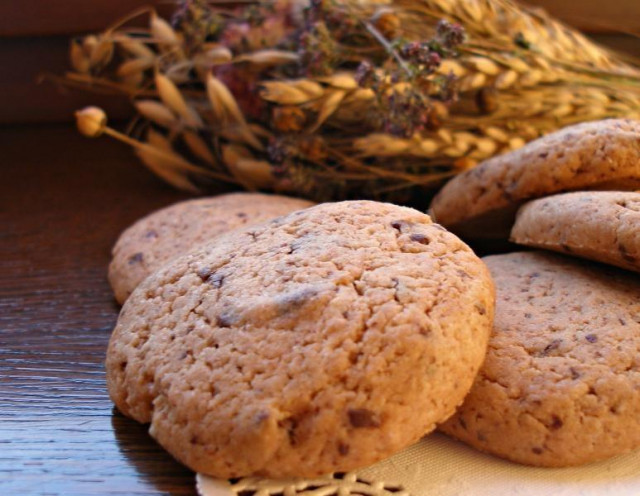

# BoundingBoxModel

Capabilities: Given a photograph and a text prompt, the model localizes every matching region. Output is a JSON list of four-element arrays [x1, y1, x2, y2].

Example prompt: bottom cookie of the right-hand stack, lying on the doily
[[440, 252, 640, 467]]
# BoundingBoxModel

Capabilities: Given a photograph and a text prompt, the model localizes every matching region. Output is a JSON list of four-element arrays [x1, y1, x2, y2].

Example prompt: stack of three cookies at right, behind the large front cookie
[[431, 120, 640, 467]]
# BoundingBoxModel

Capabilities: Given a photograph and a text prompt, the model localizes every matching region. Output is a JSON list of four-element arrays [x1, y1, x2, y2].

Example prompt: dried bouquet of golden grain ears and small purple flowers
[[66, 0, 640, 201]]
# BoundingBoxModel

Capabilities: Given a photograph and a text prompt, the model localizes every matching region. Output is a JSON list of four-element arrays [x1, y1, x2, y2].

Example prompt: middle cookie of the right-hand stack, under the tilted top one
[[511, 191, 640, 272]]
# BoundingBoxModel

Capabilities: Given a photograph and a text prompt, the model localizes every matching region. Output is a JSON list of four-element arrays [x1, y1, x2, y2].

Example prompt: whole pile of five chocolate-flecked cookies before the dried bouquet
[[107, 121, 640, 478]]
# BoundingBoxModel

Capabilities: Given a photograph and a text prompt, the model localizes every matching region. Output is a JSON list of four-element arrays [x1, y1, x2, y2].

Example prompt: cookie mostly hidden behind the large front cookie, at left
[[109, 193, 313, 304]]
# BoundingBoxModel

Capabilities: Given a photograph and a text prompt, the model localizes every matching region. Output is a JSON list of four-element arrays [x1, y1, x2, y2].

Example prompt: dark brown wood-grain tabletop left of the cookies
[[0, 126, 205, 496]]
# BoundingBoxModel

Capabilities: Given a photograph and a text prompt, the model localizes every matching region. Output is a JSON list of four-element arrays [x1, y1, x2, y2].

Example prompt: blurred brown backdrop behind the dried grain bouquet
[[0, 0, 640, 123]]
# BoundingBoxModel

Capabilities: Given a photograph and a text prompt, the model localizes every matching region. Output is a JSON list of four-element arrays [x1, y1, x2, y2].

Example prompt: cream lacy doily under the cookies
[[196, 433, 640, 496]]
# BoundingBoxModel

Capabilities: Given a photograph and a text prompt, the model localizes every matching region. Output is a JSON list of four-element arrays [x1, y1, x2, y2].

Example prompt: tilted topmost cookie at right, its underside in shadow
[[430, 119, 640, 239]]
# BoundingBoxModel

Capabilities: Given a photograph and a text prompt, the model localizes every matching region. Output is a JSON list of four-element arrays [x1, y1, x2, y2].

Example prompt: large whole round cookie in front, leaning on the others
[[106, 201, 493, 478]]
